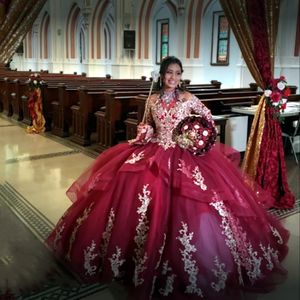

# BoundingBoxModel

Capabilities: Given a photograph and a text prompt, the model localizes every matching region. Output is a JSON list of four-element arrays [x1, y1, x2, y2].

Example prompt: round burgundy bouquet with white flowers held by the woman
[[173, 115, 218, 155]]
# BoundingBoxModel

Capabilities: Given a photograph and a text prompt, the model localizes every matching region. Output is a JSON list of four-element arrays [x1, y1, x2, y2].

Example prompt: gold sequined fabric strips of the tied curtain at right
[[220, 0, 280, 179]]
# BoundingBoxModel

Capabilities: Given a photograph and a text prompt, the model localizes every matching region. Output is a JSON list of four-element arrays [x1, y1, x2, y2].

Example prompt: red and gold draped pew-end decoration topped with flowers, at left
[[26, 73, 46, 133]]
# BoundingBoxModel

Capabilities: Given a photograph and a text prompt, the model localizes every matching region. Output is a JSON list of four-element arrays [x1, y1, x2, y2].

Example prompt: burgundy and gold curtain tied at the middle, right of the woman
[[220, 0, 295, 208]]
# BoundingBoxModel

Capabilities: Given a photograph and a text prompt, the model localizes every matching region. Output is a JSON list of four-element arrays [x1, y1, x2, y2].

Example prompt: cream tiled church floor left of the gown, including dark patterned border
[[0, 116, 118, 300]]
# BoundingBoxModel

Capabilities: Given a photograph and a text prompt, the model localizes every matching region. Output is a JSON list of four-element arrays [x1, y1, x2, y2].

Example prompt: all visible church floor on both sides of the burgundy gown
[[0, 115, 300, 300]]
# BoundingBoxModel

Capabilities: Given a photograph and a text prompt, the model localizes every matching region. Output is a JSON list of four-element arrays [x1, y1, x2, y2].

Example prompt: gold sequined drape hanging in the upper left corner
[[0, 0, 47, 64]]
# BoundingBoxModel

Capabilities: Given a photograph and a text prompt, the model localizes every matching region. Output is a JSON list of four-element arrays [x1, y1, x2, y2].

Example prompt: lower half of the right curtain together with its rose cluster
[[242, 76, 295, 208]]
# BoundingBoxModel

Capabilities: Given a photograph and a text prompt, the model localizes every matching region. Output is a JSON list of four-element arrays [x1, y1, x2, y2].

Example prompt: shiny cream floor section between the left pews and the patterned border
[[0, 118, 92, 223]]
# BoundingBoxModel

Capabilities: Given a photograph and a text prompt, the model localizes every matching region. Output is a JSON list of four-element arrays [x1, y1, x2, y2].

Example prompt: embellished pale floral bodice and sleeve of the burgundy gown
[[150, 92, 212, 149]]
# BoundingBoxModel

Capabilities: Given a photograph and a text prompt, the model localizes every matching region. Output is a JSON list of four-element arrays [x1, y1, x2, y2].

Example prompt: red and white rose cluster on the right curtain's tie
[[264, 76, 291, 118]]
